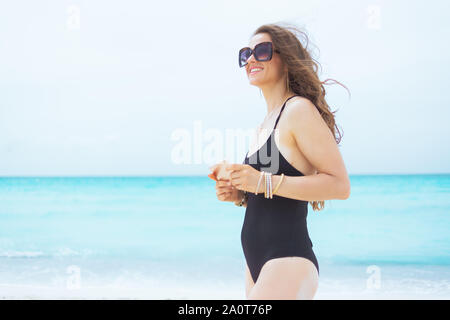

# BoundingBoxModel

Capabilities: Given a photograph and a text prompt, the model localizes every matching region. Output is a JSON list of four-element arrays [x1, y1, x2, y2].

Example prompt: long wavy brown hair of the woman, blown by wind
[[252, 23, 350, 211]]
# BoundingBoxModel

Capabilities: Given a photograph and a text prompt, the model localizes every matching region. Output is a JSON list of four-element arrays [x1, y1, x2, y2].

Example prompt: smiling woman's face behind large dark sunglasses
[[245, 33, 283, 87]]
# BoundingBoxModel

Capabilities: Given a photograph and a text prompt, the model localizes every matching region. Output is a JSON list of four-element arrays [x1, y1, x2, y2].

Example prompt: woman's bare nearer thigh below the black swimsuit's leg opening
[[249, 257, 319, 300]]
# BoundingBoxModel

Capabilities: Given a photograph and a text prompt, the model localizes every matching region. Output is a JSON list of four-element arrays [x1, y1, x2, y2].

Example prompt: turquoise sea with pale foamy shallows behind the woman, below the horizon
[[0, 174, 450, 299]]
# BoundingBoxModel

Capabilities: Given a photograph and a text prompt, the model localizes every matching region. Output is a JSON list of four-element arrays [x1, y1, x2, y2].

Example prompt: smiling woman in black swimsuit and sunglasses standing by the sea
[[211, 24, 350, 299]]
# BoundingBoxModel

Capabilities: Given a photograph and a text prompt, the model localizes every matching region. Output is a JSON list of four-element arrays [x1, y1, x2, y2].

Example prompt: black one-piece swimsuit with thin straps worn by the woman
[[241, 95, 319, 283]]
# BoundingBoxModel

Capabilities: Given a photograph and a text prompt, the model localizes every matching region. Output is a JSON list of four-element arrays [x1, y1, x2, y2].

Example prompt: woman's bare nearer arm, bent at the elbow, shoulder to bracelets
[[272, 99, 350, 201]]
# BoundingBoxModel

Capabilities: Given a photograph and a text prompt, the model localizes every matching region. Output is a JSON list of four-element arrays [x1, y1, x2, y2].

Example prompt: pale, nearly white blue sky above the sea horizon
[[0, 0, 450, 176]]
